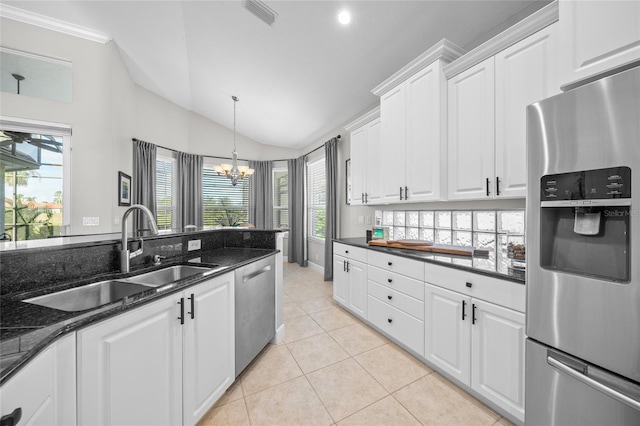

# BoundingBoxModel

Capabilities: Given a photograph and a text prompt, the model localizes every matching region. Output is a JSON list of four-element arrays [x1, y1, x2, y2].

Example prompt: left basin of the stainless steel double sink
[[24, 281, 150, 312]]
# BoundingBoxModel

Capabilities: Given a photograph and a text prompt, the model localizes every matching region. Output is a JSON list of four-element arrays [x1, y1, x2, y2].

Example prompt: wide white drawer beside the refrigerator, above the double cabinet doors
[[425, 263, 526, 312]]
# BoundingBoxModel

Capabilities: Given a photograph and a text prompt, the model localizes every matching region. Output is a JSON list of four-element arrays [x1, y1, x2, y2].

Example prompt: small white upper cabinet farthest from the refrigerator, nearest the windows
[[345, 108, 381, 205]]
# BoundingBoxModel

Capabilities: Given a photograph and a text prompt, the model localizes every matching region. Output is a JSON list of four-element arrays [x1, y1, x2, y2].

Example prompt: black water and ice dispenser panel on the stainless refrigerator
[[540, 167, 631, 283]]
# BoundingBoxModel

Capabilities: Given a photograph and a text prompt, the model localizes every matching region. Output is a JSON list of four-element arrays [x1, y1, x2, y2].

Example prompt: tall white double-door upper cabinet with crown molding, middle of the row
[[372, 40, 463, 204]]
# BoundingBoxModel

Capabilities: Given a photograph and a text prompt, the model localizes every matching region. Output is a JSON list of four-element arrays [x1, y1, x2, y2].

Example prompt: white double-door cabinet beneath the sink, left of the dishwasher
[[78, 273, 235, 425]]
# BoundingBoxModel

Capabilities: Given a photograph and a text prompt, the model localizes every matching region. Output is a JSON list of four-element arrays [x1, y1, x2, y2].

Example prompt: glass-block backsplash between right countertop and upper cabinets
[[375, 209, 526, 273]]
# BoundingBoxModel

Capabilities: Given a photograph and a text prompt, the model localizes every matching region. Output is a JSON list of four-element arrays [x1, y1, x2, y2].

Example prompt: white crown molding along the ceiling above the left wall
[[0, 4, 111, 44]]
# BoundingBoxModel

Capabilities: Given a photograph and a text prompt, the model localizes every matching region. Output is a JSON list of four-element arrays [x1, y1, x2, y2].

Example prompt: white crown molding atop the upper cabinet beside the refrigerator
[[442, 1, 559, 79]]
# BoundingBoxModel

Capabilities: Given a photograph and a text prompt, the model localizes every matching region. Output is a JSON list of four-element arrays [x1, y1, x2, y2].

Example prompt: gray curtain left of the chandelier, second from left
[[175, 152, 202, 230]]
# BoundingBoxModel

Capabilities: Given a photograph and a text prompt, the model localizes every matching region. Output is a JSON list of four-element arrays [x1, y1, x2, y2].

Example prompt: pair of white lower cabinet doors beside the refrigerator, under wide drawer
[[425, 284, 525, 421]]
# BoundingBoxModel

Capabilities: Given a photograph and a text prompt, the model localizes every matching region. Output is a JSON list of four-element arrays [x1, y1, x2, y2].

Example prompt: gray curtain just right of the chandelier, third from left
[[249, 161, 273, 229]]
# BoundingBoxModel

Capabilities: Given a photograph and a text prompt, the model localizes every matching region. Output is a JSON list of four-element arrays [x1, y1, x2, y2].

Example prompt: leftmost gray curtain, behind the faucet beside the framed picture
[[133, 139, 157, 230]]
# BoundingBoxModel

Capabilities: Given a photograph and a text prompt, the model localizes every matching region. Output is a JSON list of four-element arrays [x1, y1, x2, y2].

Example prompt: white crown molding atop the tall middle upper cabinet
[[371, 38, 465, 96]]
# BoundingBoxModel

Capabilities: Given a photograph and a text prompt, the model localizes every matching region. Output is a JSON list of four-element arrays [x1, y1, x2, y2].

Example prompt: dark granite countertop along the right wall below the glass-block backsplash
[[334, 238, 525, 284]]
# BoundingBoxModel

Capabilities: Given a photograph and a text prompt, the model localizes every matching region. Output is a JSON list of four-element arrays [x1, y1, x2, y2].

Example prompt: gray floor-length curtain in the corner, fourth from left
[[287, 155, 307, 266]]
